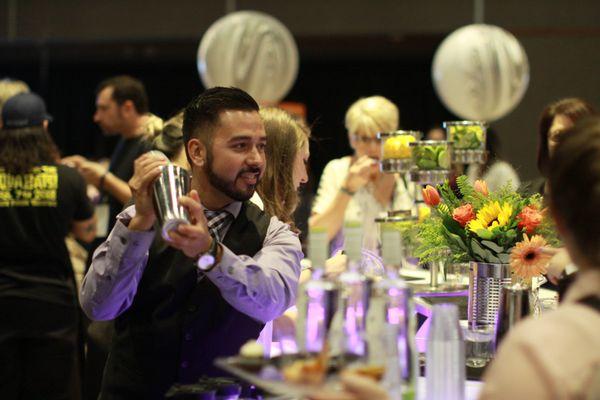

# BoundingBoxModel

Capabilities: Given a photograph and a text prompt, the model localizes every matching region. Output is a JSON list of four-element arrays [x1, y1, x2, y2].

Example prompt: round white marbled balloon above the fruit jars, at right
[[431, 24, 529, 121]]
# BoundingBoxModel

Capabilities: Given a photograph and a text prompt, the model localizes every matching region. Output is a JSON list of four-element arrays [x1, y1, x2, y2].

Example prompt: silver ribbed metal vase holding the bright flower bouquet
[[467, 261, 511, 326]]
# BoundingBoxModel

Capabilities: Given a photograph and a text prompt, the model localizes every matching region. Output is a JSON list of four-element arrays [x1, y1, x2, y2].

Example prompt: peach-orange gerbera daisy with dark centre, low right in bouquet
[[510, 234, 551, 279]]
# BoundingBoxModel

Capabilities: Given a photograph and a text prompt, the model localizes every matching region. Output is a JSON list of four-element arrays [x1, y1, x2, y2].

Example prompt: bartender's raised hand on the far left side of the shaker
[[129, 154, 168, 231]]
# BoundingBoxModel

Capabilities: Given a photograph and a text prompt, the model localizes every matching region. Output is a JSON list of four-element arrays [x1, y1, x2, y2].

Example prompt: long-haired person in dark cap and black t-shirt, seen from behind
[[0, 93, 95, 399]]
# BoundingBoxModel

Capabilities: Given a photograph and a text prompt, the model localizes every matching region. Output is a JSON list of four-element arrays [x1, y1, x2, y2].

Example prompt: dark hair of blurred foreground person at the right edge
[[549, 116, 600, 266]]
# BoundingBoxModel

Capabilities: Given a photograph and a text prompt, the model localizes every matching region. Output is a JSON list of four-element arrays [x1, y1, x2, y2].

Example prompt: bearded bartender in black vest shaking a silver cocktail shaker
[[80, 88, 302, 399]]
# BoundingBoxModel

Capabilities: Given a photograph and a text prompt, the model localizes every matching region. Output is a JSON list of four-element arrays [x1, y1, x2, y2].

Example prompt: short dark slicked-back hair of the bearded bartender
[[183, 86, 259, 152]]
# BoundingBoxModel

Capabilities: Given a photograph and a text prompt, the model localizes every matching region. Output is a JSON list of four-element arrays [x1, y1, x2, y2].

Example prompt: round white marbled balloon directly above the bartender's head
[[197, 11, 298, 103]]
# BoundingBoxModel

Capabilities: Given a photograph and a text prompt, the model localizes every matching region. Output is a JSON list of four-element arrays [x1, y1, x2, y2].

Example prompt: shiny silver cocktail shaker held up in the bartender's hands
[[153, 164, 190, 240]]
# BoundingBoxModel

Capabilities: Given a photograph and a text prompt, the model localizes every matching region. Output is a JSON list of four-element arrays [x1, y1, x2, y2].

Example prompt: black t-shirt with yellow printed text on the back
[[0, 165, 93, 305]]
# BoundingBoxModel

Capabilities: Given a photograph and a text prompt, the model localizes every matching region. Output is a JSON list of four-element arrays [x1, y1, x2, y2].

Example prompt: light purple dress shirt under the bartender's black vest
[[80, 202, 303, 322]]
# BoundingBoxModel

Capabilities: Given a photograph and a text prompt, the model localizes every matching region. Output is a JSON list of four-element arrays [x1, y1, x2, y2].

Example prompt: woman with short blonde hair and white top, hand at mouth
[[309, 96, 413, 253]]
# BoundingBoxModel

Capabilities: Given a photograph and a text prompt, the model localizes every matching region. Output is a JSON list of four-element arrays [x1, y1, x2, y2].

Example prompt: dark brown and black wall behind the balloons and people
[[0, 0, 600, 183]]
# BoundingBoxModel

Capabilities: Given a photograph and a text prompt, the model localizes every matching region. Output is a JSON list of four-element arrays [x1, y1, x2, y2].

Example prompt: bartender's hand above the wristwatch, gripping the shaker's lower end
[[169, 190, 213, 258]]
